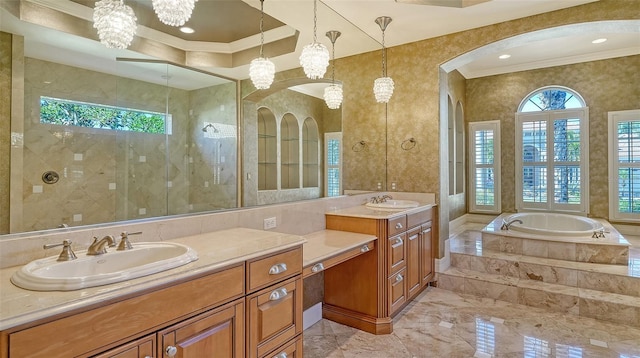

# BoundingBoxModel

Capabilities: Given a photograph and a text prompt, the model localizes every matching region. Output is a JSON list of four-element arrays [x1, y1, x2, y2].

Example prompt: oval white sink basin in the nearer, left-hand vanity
[[11, 242, 198, 291]]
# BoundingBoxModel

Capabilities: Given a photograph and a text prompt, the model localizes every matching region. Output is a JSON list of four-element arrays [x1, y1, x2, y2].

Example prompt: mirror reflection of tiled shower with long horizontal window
[[3, 56, 237, 233]]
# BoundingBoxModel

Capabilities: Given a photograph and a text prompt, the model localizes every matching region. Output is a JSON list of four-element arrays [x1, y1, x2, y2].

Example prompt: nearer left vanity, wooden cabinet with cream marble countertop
[[0, 228, 305, 358]]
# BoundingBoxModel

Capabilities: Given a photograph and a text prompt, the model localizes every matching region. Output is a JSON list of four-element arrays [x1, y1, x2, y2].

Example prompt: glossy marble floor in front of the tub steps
[[304, 287, 640, 358]]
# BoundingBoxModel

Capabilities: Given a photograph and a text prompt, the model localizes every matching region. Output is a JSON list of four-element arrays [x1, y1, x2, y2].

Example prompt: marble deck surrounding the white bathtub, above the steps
[[482, 213, 631, 265]]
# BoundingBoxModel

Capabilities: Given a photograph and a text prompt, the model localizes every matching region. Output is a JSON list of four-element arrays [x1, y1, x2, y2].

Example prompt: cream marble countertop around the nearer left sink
[[0, 228, 305, 330]]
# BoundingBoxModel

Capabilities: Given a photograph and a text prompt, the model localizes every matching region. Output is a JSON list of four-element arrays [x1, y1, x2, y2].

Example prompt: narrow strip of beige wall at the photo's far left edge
[[0, 32, 12, 234]]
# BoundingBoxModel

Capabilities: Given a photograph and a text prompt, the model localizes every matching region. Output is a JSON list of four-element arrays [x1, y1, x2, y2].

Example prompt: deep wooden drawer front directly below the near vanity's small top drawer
[[247, 276, 302, 358]]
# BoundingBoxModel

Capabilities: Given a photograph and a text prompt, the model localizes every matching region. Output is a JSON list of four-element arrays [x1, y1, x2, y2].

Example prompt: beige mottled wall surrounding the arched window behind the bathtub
[[467, 56, 640, 218]]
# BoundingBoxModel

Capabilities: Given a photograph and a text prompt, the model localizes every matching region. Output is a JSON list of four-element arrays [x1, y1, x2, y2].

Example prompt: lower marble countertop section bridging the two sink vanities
[[302, 230, 377, 267]]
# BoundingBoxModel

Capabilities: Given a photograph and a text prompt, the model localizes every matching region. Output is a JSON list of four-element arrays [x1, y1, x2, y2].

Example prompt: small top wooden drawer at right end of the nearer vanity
[[247, 246, 302, 292]]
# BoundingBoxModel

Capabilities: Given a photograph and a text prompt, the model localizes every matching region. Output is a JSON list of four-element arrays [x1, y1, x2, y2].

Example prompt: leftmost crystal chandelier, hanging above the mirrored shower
[[93, 0, 137, 49]]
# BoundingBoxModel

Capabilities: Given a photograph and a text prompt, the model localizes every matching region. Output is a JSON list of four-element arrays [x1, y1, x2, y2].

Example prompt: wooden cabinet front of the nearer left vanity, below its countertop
[[0, 245, 302, 358]]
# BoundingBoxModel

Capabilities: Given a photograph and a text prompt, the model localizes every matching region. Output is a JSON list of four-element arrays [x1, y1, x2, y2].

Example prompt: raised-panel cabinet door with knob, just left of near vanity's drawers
[[158, 299, 244, 358]]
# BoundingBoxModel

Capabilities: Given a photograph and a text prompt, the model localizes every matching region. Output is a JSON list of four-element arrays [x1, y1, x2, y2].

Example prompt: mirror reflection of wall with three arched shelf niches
[[242, 78, 342, 206]]
